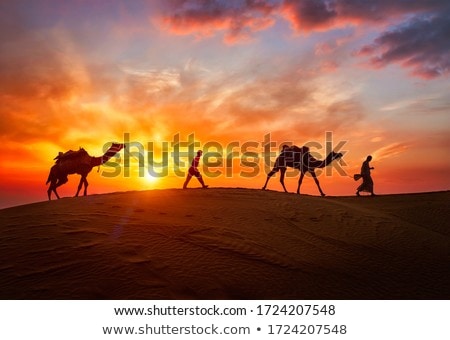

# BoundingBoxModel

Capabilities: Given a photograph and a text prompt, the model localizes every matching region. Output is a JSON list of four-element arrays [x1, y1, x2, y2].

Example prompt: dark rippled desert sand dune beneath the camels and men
[[0, 188, 450, 299]]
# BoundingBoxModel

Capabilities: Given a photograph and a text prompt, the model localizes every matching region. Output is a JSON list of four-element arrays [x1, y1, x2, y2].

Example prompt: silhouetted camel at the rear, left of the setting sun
[[45, 143, 125, 200]]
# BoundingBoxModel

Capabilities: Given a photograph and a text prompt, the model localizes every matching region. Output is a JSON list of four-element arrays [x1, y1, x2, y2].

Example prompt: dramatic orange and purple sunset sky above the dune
[[0, 0, 450, 207]]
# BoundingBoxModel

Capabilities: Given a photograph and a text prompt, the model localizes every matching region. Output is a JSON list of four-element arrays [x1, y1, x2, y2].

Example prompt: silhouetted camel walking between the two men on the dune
[[262, 145, 343, 196]]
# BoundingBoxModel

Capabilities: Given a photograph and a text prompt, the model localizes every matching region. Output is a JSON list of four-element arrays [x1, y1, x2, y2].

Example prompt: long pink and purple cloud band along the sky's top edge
[[156, 0, 447, 40]]
